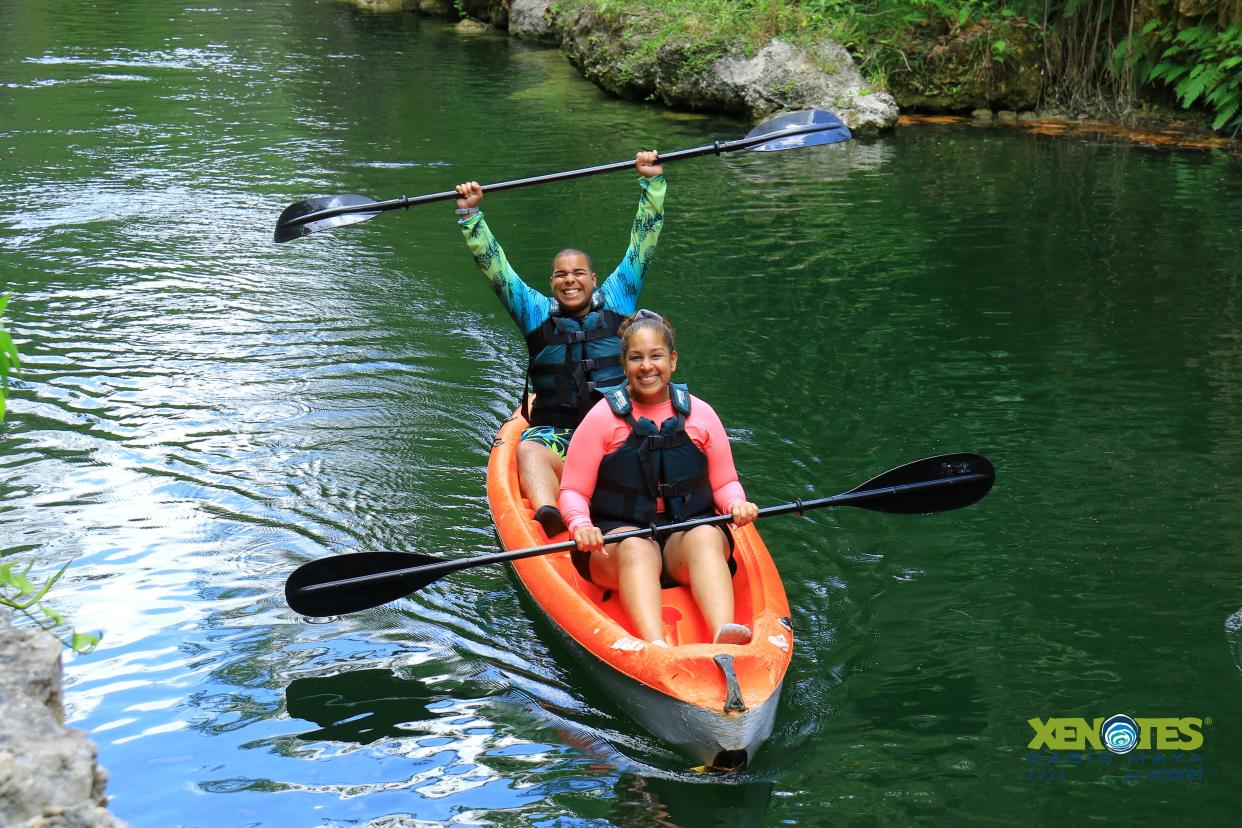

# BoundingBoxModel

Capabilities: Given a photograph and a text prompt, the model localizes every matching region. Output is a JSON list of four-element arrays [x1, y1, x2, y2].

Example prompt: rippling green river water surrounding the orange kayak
[[0, 0, 1242, 828]]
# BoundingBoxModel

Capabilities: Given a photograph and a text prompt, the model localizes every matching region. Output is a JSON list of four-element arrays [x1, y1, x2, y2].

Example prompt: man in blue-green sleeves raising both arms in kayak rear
[[457, 151, 667, 538]]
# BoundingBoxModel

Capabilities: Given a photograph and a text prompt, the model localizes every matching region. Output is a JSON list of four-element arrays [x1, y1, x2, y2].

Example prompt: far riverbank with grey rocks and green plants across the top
[[347, 0, 1242, 153]]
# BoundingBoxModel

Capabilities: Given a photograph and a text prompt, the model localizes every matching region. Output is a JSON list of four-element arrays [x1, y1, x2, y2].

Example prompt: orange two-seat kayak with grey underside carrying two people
[[487, 413, 794, 768]]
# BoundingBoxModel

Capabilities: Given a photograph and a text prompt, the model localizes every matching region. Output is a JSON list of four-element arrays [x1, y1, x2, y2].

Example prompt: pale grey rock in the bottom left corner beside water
[[0, 616, 125, 828]]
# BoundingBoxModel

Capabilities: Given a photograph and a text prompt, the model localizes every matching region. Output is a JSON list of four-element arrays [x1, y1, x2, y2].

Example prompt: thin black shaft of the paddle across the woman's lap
[[301, 473, 989, 592]]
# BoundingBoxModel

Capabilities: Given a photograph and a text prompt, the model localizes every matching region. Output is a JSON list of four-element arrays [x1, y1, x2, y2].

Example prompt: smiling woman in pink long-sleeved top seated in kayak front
[[559, 310, 759, 647]]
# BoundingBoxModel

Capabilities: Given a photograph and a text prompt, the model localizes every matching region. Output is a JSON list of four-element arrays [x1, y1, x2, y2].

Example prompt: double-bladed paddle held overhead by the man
[[274, 109, 852, 242]]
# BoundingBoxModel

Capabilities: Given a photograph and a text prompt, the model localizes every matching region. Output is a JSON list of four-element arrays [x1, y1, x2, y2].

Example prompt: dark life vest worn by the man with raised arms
[[522, 290, 625, 428]]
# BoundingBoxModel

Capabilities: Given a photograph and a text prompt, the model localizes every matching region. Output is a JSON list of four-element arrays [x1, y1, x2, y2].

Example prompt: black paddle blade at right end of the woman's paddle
[[851, 452, 996, 515]]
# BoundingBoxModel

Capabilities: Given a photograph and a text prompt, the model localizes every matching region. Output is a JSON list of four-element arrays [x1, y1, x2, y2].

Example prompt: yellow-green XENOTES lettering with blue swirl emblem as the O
[[1027, 714, 1203, 754]]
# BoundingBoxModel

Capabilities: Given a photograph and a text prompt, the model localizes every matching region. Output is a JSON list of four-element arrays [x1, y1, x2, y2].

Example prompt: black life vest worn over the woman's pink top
[[591, 382, 714, 526]]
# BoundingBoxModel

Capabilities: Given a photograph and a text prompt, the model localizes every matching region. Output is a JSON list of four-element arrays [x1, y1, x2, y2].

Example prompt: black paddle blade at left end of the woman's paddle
[[284, 552, 443, 618]]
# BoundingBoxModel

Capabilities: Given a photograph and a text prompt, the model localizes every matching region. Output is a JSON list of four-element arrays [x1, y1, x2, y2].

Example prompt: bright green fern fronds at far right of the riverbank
[[1144, 15, 1242, 135]]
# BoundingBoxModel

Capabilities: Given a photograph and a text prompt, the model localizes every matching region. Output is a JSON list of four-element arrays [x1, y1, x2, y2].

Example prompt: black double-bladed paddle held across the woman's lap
[[284, 453, 996, 617]]
